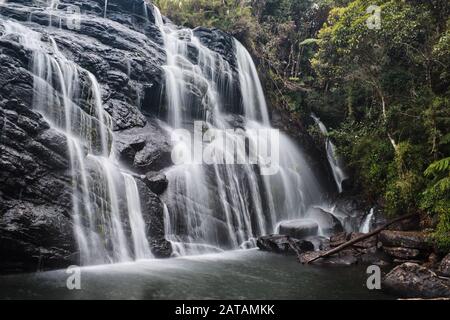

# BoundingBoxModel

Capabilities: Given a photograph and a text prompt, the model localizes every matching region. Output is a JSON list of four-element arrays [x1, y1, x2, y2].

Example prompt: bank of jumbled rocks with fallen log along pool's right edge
[[257, 218, 450, 299]]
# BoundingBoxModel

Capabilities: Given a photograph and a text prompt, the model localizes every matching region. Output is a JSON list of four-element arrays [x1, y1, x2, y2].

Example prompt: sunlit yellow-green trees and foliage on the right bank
[[306, 0, 450, 249]]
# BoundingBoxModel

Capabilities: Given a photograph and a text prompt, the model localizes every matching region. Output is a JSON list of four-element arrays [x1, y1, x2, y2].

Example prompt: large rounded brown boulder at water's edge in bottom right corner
[[383, 262, 450, 299]]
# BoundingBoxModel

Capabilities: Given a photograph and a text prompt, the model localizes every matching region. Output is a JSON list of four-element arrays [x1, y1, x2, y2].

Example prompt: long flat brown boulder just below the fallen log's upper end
[[378, 230, 430, 250]]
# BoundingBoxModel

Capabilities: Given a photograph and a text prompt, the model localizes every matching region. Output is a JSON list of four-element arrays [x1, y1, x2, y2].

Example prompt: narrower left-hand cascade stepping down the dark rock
[[3, 19, 151, 264]]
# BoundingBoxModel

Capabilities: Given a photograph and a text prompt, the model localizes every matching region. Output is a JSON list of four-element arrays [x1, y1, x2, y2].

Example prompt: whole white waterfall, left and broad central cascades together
[[1, 1, 334, 265]]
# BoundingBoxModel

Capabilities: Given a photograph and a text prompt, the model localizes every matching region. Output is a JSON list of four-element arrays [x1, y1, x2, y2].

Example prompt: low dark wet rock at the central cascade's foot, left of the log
[[256, 234, 314, 254]]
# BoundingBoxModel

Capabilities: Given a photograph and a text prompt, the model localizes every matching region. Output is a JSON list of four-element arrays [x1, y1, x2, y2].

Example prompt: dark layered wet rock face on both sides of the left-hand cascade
[[0, 0, 235, 271]]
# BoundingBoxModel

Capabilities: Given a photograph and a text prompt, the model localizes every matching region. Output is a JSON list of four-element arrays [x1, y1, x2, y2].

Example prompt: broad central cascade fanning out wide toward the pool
[[153, 7, 323, 255]]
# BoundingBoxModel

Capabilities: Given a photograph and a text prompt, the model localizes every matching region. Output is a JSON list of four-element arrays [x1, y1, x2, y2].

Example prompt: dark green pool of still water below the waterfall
[[0, 250, 390, 299]]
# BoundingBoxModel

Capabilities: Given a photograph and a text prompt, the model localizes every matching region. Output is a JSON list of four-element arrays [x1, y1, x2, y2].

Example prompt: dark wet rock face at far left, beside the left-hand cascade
[[0, 99, 76, 272]]
